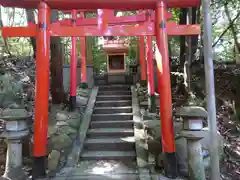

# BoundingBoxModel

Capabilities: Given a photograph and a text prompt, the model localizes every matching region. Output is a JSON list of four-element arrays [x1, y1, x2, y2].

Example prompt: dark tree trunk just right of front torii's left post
[[50, 10, 67, 104]]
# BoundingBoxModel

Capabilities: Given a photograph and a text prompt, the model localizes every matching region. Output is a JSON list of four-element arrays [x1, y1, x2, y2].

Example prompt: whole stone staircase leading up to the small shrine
[[80, 85, 136, 162]]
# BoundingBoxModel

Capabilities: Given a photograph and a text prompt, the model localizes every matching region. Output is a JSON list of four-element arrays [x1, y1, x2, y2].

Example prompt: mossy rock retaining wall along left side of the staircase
[[48, 89, 91, 176]]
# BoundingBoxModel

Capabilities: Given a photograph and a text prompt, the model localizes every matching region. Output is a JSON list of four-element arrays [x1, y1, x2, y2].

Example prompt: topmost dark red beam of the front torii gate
[[0, 0, 201, 10]]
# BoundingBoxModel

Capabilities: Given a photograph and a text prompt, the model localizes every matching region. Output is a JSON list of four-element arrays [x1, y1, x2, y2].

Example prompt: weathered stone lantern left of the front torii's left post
[[0, 109, 29, 180]]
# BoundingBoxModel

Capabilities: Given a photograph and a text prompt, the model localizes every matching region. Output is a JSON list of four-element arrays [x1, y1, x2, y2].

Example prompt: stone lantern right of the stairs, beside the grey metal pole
[[176, 106, 208, 180]]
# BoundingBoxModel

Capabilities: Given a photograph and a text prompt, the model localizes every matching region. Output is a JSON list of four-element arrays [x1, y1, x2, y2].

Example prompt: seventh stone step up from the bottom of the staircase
[[95, 100, 132, 107]]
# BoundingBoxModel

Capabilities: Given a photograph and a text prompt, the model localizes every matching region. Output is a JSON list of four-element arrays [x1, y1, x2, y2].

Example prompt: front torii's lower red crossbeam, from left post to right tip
[[50, 22, 200, 36]]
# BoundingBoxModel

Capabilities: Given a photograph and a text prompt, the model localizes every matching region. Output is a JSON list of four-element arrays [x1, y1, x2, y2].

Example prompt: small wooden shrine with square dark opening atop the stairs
[[103, 38, 129, 74]]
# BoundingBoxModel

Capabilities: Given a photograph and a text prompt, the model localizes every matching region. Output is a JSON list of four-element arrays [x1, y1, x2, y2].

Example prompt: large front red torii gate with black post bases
[[0, 0, 200, 178]]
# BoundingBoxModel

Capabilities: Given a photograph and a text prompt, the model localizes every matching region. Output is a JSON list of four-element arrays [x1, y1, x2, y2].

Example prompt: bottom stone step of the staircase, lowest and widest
[[81, 151, 136, 162]]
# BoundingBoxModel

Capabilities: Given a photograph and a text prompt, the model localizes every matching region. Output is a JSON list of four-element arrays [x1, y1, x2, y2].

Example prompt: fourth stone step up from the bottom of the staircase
[[90, 120, 133, 128]]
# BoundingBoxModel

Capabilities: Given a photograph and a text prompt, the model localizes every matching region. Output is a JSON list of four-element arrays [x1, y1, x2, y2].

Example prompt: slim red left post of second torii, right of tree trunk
[[70, 10, 77, 97]]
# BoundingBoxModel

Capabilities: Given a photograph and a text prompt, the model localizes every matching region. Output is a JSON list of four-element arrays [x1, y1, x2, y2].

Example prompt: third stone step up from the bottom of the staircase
[[87, 128, 134, 138]]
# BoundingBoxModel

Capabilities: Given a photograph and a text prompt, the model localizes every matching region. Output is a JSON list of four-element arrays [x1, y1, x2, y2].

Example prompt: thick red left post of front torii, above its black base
[[33, 2, 50, 157]]
